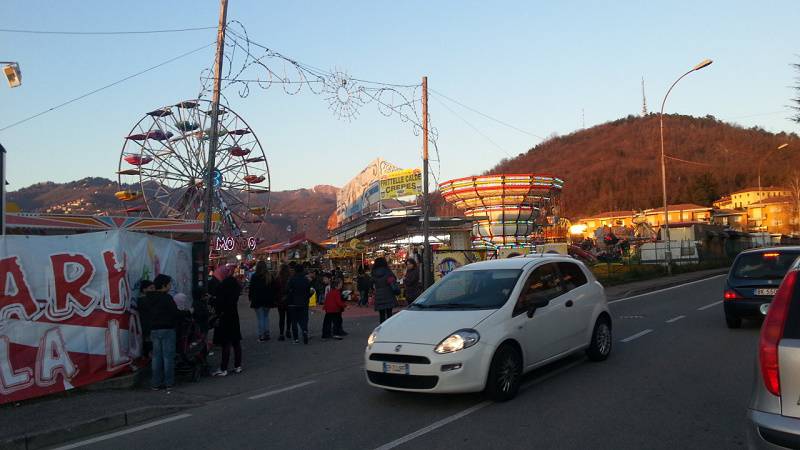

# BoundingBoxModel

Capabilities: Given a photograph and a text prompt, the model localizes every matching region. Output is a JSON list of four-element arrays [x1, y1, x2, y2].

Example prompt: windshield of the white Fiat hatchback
[[412, 269, 522, 309]]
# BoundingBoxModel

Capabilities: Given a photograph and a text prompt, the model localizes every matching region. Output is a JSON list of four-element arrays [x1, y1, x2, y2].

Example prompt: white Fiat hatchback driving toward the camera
[[364, 255, 612, 401]]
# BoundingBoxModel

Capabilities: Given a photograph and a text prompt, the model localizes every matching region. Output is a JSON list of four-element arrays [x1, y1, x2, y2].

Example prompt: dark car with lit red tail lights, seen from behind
[[724, 247, 800, 328]]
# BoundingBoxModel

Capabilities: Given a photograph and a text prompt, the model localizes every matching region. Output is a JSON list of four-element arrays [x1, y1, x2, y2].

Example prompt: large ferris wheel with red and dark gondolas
[[116, 99, 270, 237]]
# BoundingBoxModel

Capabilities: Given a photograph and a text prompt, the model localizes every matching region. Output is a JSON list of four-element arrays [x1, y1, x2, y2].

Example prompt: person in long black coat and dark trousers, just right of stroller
[[212, 265, 242, 377]]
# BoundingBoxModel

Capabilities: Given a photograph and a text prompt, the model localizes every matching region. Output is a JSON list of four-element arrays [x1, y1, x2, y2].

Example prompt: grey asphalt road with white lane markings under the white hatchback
[[54, 277, 760, 450]]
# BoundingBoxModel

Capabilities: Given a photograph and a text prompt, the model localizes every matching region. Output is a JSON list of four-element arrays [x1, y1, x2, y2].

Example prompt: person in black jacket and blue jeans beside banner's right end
[[138, 274, 181, 390]]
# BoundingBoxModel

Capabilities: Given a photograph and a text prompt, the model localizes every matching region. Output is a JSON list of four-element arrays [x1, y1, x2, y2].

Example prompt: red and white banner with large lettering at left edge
[[0, 231, 192, 404]]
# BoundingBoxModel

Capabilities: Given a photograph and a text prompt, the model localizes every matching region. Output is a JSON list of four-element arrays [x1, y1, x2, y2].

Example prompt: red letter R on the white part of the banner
[[50, 254, 94, 316]]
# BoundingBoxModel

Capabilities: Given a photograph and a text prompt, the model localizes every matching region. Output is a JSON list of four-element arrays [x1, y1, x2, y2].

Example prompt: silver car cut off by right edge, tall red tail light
[[747, 261, 800, 449]]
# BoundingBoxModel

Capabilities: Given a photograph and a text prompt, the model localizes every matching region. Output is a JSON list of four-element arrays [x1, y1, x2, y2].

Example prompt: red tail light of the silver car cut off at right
[[758, 270, 798, 396]]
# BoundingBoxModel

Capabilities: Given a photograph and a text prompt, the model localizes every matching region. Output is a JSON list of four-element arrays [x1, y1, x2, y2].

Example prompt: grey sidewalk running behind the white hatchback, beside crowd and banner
[[0, 269, 727, 450]]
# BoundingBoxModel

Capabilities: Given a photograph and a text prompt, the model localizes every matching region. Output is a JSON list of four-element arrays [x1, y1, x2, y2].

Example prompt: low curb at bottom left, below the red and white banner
[[0, 404, 192, 450]]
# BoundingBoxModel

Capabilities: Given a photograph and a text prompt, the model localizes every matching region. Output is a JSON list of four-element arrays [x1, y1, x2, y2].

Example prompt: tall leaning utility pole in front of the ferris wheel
[[202, 0, 228, 291]]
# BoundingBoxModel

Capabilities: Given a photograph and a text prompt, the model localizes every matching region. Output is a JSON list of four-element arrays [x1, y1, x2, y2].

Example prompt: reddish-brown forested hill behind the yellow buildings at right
[[486, 114, 800, 217]]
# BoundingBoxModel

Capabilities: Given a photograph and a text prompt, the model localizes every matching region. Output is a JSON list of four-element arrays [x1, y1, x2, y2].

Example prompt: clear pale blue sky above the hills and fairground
[[0, 0, 800, 190]]
